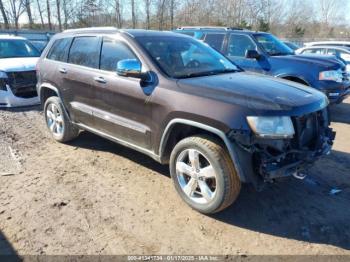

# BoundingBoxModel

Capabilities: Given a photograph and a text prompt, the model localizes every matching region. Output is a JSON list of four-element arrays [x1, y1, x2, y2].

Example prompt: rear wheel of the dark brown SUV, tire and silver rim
[[44, 96, 79, 143]]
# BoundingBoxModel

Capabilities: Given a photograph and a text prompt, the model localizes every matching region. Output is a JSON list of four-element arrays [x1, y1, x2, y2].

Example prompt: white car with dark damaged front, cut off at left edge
[[0, 35, 40, 107]]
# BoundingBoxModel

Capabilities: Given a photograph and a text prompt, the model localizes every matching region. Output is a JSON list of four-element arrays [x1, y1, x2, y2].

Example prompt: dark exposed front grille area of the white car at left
[[7, 71, 37, 98]]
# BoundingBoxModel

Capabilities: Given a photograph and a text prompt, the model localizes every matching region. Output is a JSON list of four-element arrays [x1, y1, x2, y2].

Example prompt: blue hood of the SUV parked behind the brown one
[[271, 55, 345, 70]]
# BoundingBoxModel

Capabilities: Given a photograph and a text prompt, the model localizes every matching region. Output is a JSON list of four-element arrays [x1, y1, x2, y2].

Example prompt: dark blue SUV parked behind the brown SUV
[[175, 27, 350, 103]]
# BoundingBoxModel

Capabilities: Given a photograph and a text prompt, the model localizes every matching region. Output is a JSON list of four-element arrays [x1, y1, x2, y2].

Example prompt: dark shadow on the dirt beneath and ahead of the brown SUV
[[70, 132, 350, 249]]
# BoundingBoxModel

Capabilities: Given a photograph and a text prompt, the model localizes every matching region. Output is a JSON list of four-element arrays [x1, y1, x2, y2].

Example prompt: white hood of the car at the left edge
[[0, 57, 39, 72]]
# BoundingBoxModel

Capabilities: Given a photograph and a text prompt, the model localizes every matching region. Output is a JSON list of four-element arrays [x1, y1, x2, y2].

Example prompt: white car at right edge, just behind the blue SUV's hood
[[295, 45, 350, 73]]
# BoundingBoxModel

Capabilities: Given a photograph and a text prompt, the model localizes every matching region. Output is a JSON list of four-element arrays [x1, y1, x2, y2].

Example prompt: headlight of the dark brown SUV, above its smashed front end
[[247, 116, 295, 139]]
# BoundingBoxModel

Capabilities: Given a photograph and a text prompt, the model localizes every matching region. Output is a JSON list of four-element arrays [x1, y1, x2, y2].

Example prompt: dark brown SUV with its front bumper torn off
[[38, 28, 334, 213]]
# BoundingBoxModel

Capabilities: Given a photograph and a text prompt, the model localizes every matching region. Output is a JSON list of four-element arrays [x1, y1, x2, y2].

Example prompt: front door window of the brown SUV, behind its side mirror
[[100, 38, 137, 71]]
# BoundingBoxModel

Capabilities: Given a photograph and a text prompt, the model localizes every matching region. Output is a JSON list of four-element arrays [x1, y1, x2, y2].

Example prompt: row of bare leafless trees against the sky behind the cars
[[0, 0, 350, 38]]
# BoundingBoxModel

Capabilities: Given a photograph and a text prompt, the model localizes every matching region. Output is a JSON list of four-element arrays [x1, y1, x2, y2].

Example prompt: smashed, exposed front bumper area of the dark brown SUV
[[228, 108, 335, 185]]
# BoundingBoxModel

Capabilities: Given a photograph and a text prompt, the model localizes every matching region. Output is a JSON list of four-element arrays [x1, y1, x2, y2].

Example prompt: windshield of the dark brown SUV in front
[[136, 36, 238, 78]]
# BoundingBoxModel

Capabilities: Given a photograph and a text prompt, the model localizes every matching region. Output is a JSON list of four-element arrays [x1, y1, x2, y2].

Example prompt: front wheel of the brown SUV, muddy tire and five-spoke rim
[[170, 136, 241, 214]]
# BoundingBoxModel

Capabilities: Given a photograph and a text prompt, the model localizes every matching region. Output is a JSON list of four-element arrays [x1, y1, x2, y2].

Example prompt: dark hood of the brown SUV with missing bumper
[[178, 72, 328, 115]]
